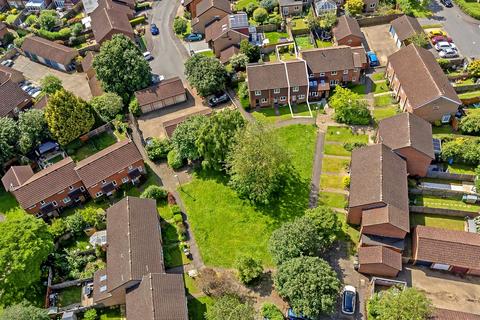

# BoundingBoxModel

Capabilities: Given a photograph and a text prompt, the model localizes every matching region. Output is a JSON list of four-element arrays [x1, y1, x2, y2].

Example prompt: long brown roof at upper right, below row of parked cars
[[388, 44, 461, 109]]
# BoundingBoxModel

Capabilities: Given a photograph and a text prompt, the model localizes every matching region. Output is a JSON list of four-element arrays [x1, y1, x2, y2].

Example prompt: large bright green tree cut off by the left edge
[[0, 213, 53, 305]]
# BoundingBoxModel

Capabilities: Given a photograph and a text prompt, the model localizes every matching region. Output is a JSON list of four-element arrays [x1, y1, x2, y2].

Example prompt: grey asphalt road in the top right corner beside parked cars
[[418, 0, 480, 58]]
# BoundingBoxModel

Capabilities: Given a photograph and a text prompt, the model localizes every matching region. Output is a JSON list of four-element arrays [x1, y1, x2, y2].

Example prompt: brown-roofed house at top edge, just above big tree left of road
[[90, 0, 135, 44]]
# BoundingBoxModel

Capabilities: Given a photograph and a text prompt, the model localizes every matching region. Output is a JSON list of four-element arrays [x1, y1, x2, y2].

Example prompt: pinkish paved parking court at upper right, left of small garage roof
[[361, 24, 399, 66]]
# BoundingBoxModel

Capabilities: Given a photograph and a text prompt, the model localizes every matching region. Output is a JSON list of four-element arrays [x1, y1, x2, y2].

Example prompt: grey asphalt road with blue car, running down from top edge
[[146, 0, 188, 79]]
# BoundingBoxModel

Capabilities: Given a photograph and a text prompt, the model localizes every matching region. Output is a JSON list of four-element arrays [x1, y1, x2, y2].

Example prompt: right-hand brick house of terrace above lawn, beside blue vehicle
[[301, 46, 367, 99]]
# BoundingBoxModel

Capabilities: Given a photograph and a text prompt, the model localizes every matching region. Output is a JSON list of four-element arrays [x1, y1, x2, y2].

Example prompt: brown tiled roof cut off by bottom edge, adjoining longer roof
[[126, 273, 188, 320]]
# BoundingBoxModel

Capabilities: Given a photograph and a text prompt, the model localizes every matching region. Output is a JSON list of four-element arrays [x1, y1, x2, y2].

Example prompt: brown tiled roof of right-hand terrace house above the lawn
[[301, 46, 355, 73]]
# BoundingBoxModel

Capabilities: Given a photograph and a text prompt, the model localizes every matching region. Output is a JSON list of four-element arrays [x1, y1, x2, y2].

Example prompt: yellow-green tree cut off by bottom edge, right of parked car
[[367, 287, 433, 320]]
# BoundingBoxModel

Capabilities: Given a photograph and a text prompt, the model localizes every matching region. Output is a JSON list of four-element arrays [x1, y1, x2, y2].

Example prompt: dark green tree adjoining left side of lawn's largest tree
[[197, 109, 245, 171]]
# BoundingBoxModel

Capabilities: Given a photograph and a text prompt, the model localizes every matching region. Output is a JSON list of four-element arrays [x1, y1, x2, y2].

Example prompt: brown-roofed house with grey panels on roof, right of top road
[[205, 12, 249, 61]]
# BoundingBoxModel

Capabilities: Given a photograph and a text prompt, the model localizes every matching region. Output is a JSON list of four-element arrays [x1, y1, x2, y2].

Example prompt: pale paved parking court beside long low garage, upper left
[[13, 55, 92, 101]]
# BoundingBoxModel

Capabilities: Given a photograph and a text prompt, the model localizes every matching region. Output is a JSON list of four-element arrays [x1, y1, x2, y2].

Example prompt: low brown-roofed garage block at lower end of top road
[[135, 77, 187, 113]]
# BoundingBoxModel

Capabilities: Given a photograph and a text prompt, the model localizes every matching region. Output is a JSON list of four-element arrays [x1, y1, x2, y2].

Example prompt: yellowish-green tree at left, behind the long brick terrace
[[45, 89, 95, 145]]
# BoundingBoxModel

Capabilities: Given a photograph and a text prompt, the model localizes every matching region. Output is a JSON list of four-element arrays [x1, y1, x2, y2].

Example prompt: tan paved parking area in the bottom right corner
[[398, 265, 480, 314]]
